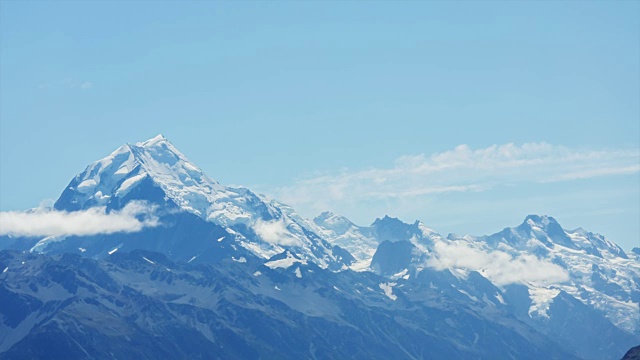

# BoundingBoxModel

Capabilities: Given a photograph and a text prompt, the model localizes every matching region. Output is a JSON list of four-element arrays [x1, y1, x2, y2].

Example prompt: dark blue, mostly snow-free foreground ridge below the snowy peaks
[[0, 250, 576, 359]]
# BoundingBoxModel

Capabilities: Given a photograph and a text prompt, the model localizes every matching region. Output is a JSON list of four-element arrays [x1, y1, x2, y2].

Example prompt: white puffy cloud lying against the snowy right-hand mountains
[[427, 241, 569, 286]]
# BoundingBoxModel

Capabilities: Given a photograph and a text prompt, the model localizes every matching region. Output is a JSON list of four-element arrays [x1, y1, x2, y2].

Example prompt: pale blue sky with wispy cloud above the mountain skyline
[[0, 1, 640, 249]]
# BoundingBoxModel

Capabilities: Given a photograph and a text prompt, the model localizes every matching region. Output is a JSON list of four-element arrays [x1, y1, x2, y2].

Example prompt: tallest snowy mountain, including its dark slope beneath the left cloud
[[26, 135, 353, 270]]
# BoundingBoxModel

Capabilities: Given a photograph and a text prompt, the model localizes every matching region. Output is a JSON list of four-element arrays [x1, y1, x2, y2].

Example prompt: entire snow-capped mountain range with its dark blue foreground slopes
[[0, 135, 640, 359]]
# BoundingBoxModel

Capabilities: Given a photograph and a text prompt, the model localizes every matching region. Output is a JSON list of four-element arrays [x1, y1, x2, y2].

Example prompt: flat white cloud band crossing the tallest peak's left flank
[[0, 202, 159, 236]]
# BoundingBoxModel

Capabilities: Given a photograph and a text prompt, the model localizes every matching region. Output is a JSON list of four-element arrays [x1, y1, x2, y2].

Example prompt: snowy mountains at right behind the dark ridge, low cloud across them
[[362, 215, 640, 359]]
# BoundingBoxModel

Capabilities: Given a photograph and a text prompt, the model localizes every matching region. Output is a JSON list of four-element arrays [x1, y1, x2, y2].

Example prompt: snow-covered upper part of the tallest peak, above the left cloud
[[55, 135, 350, 269]]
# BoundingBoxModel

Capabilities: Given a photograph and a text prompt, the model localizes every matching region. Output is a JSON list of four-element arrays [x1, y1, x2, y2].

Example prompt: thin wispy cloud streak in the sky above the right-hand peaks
[[274, 143, 640, 215]]
